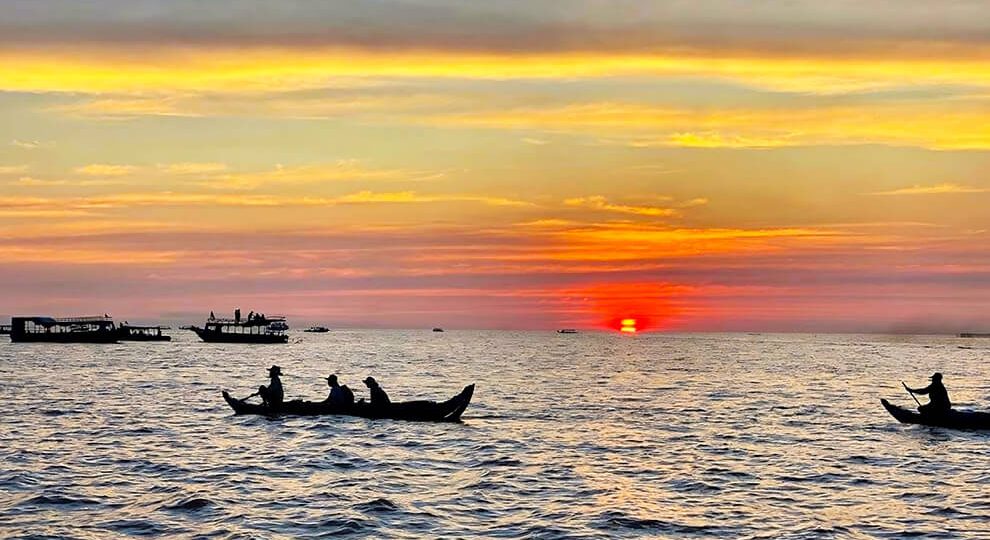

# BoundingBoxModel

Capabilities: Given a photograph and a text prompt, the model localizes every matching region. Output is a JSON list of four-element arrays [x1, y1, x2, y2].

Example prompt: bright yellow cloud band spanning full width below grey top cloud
[[0, 46, 990, 95]]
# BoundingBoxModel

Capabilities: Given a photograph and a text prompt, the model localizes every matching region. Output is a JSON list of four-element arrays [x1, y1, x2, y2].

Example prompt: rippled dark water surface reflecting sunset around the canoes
[[0, 331, 990, 538]]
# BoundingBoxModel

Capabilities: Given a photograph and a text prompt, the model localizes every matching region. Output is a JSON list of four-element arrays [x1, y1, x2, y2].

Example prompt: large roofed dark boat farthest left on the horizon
[[10, 315, 118, 343]]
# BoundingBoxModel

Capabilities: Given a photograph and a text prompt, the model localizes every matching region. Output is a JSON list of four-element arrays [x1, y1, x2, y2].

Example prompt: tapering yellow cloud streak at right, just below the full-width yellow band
[[434, 101, 990, 150]]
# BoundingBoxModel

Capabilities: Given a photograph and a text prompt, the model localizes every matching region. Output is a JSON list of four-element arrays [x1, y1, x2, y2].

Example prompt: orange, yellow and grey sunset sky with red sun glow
[[0, 0, 990, 332]]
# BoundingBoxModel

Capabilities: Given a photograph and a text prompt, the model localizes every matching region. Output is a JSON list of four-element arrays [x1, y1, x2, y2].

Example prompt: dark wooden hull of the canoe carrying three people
[[223, 384, 474, 422]]
